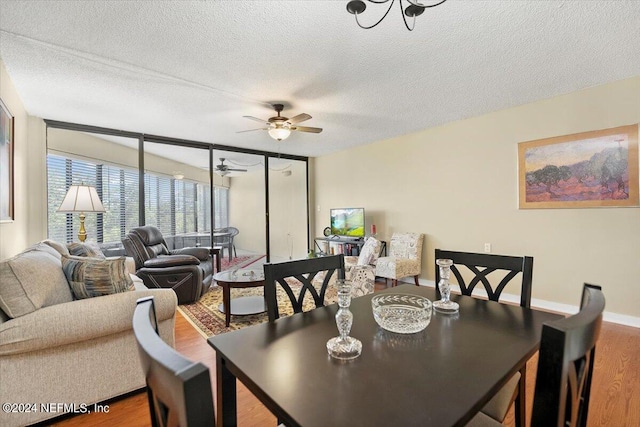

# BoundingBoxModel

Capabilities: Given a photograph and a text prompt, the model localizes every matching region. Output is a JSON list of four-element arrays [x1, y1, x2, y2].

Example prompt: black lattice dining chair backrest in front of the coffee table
[[264, 254, 344, 322]]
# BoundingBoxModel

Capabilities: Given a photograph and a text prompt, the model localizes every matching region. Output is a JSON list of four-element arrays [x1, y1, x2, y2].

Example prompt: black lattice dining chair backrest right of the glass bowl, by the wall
[[435, 249, 533, 307]]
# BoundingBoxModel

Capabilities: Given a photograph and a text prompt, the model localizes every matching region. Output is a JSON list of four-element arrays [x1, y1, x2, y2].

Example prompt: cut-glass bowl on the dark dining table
[[371, 294, 432, 334]]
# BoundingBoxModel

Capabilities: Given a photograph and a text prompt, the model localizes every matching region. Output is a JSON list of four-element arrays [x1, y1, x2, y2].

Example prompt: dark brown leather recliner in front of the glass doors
[[122, 225, 213, 304]]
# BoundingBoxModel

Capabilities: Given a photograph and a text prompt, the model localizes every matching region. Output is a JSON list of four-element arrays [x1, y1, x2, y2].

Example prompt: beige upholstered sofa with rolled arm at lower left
[[0, 242, 177, 426]]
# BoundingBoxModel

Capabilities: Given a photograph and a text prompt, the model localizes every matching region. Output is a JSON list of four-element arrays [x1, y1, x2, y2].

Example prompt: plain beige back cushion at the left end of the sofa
[[0, 247, 73, 318]]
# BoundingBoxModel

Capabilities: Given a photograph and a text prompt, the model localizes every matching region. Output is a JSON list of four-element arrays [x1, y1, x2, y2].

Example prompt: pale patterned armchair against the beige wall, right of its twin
[[375, 233, 424, 286]]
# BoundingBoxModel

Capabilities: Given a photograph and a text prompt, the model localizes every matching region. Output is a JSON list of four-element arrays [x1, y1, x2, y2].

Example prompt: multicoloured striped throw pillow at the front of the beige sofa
[[62, 255, 134, 299]]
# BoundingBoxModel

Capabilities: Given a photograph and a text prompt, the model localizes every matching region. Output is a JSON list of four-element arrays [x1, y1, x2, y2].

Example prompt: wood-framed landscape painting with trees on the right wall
[[518, 125, 638, 209]]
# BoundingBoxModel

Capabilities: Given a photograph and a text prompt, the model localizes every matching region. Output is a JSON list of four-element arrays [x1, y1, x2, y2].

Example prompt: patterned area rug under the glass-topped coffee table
[[178, 280, 337, 338]]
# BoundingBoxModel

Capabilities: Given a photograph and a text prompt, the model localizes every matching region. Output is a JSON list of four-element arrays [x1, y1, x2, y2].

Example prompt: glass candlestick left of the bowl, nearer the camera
[[327, 279, 362, 360]]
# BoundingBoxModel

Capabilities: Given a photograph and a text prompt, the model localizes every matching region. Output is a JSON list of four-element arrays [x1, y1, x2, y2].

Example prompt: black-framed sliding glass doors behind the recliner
[[45, 120, 309, 262]]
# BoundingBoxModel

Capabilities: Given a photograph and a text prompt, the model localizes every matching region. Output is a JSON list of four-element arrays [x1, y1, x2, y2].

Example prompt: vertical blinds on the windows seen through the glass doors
[[47, 154, 229, 244]]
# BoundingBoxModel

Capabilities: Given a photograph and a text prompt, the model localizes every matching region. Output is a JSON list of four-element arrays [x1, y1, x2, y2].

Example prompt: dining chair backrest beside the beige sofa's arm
[[133, 297, 215, 427]]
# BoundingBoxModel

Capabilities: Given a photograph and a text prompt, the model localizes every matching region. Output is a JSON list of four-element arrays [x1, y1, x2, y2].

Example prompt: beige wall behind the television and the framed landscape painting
[[312, 77, 640, 324]]
